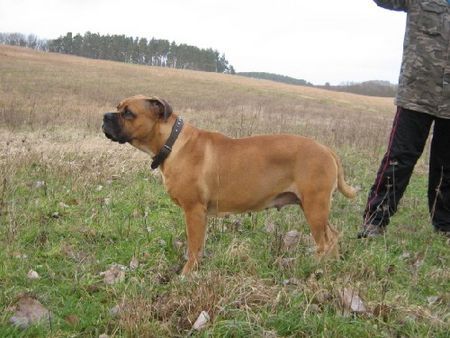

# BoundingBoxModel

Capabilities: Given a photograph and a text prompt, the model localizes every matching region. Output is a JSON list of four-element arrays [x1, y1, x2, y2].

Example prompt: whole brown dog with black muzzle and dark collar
[[103, 96, 356, 274]]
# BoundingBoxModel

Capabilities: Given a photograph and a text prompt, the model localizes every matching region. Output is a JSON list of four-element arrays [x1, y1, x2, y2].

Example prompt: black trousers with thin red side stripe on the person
[[364, 107, 450, 231]]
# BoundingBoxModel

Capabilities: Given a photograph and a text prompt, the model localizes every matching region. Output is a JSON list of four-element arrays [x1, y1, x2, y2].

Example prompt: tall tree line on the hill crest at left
[[0, 32, 235, 74]]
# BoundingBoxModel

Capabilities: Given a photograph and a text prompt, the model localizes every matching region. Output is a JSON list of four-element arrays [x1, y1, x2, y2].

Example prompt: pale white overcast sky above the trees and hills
[[0, 0, 406, 84]]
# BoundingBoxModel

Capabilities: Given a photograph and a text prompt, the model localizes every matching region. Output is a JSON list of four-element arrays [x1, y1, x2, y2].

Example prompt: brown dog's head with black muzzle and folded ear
[[102, 95, 172, 148]]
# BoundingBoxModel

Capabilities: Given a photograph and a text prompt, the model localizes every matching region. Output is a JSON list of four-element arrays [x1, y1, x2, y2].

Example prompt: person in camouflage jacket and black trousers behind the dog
[[358, 0, 450, 238]]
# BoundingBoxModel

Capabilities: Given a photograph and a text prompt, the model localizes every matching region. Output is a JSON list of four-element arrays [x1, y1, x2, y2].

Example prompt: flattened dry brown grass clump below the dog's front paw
[[114, 273, 282, 335]]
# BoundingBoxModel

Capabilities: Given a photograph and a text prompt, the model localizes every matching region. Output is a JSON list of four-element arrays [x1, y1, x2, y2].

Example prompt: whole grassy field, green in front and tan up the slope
[[0, 46, 450, 337]]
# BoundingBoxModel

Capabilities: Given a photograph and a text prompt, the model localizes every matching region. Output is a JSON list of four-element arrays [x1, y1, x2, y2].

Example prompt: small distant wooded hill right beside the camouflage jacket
[[317, 80, 397, 97]]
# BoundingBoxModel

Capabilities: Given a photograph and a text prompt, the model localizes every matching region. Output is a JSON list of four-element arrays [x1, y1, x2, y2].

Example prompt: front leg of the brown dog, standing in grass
[[181, 204, 206, 275]]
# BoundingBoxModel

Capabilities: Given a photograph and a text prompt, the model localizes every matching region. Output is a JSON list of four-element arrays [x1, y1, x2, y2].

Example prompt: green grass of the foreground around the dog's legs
[[0, 152, 450, 337]]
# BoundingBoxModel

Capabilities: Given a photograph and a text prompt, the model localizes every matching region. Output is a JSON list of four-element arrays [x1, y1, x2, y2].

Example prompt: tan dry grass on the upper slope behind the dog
[[0, 46, 394, 153]]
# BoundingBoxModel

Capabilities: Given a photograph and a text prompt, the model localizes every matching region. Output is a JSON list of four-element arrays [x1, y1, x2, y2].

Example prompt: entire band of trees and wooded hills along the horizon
[[0, 32, 397, 97]]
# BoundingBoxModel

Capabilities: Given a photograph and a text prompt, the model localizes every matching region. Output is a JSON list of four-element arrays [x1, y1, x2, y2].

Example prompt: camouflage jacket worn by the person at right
[[374, 0, 450, 118]]
